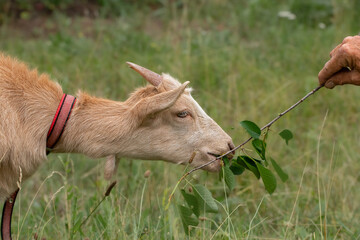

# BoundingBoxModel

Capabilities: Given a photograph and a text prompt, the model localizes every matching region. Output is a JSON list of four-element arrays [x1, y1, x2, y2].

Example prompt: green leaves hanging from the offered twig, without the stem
[[178, 121, 292, 234]]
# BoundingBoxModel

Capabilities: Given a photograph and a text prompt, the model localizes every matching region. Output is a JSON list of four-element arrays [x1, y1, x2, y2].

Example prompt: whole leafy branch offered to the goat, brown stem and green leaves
[[175, 86, 322, 234]]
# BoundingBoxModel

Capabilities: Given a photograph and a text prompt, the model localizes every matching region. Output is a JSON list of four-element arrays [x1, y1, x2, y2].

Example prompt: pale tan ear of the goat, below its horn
[[132, 82, 189, 121]]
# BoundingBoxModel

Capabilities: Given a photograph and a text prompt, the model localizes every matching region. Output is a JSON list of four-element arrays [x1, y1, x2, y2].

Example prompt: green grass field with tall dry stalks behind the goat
[[0, 0, 360, 240]]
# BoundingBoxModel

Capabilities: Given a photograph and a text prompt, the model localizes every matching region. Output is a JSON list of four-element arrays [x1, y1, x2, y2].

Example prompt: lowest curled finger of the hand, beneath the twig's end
[[325, 70, 360, 89]]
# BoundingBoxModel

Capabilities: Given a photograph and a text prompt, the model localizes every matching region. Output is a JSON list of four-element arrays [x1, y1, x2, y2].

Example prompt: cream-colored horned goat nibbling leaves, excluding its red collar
[[0, 55, 233, 198]]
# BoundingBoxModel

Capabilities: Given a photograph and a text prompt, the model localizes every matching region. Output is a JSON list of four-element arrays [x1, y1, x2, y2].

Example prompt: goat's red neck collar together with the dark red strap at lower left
[[1, 93, 76, 240]]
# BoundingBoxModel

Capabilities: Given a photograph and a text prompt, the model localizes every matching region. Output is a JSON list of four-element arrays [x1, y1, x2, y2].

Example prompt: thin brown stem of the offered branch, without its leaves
[[183, 86, 323, 177]]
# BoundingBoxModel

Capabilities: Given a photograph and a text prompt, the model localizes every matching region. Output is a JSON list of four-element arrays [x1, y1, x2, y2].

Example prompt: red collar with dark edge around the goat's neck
[[46, 93, 76, 154]]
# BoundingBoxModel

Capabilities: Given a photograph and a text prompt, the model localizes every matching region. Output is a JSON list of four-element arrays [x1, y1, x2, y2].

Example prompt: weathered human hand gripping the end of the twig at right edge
[[318, 36, 360, 88]]
